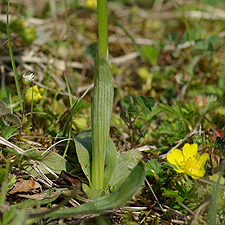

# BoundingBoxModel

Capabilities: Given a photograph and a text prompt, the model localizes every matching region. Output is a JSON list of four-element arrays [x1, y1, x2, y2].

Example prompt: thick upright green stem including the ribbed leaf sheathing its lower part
[[90, 0, 114, 190]]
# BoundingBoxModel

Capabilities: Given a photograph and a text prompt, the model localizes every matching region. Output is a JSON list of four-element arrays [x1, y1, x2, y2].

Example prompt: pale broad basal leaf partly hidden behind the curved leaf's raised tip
[[110, 149, 143, 190]]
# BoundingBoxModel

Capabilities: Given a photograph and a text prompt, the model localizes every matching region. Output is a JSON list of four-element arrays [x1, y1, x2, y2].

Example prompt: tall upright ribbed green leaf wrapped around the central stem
[[91, 51, 114, 190]]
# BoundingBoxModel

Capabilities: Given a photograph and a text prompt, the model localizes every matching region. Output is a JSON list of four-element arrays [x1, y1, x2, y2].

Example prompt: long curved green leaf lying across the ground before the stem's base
[[35, 161, 145, 217]]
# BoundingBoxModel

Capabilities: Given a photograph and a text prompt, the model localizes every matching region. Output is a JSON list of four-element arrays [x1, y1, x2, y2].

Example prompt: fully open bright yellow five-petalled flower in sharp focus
[[167, 144, 209, 179]]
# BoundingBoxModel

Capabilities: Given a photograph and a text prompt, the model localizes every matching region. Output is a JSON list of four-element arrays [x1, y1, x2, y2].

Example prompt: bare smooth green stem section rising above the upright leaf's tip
[[97, 0, 108, 59]]
